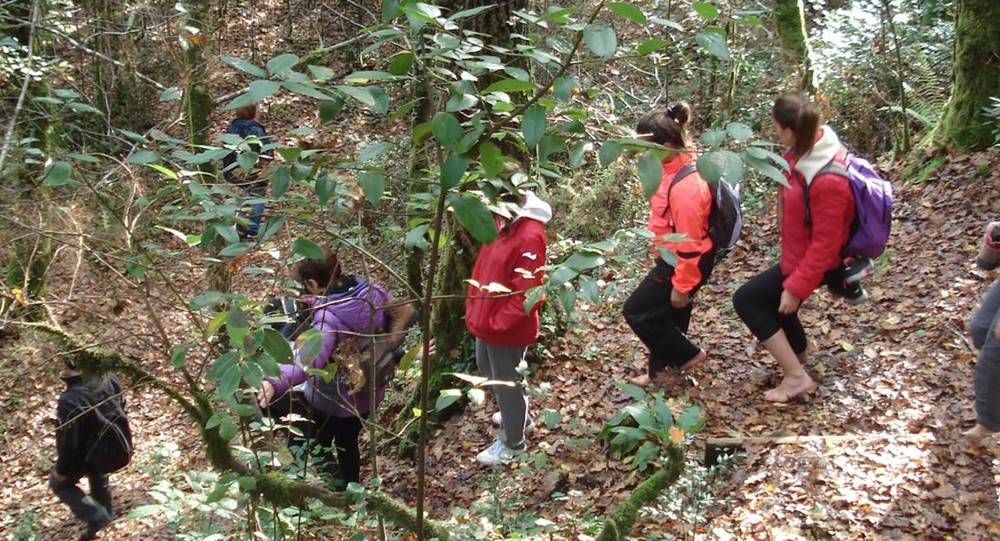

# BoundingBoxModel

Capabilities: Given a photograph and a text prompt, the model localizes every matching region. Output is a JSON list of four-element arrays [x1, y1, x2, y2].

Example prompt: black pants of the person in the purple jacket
[[265, 391, 367, 484]]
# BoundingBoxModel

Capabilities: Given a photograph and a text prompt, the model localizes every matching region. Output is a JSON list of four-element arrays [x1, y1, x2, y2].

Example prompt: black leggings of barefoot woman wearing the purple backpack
[[733, 265, 844, 355]]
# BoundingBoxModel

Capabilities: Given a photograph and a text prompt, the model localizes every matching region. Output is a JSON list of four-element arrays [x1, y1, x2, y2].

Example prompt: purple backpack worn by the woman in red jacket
[[804, 154, 892, 259]]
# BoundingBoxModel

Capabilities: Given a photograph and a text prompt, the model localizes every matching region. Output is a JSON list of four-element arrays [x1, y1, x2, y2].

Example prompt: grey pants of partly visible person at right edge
[[970, 280, 1000, 432]]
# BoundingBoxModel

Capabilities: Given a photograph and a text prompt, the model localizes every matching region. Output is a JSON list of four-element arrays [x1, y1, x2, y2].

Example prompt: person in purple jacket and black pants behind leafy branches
[[258, 252, 415, 484]]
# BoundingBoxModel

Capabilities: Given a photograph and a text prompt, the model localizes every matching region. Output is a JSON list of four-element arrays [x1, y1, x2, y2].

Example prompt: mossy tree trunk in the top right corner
[[931, 0, 1000, 152]]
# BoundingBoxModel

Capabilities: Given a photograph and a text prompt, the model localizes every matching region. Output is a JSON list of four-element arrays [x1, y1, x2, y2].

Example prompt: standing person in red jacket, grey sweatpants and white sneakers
[[465, 191, 552, 465]]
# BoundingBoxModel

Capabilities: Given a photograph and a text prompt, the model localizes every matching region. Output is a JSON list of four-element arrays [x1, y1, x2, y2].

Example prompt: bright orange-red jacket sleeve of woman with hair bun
[[670, 178, 712, 293]]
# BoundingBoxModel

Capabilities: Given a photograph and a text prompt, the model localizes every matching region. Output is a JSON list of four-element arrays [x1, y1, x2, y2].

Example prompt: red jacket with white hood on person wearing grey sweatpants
[[465, 192, 552, 347]]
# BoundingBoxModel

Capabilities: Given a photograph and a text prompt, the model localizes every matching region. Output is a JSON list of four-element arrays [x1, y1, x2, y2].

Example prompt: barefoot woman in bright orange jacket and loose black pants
[[623, 102, 715, 387]]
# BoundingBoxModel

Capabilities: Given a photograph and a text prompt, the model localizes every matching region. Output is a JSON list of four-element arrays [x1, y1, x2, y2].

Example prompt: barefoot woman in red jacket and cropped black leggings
[[733, 94, 864, 402]]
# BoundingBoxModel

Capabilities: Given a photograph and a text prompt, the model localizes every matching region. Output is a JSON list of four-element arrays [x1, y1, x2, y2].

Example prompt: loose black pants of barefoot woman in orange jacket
[[623, 253, 715, 377]]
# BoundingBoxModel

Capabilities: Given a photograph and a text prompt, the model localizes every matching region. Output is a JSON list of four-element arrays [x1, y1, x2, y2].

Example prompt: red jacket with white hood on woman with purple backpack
[[780, 126, 854, 300]]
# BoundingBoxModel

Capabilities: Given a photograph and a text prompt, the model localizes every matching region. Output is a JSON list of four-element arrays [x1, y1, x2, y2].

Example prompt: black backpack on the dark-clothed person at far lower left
[[84, 378, 135, 474]]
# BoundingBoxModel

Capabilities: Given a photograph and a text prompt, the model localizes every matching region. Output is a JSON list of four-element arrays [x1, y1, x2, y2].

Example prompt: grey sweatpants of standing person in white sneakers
[[476, 338, 528, 449]]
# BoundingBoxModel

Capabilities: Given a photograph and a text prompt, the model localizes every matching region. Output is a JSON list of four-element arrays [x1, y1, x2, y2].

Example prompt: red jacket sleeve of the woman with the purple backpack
[[783, 175, 854, 300]]
